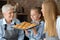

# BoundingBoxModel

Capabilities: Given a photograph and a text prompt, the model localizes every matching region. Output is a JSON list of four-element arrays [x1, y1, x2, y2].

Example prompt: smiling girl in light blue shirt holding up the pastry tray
[[25, 7, 44, 40]]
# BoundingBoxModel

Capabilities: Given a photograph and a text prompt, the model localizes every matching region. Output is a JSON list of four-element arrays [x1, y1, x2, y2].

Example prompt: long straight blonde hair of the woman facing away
[[42, 0, 57, 36]]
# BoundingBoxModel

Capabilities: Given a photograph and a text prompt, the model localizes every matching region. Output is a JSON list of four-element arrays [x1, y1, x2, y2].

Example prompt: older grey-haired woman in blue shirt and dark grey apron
[[0, 4, 24, 40]]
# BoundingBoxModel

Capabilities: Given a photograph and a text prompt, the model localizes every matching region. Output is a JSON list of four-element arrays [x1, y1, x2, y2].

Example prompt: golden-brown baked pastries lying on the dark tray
[[14, 22, 36, 29]]
